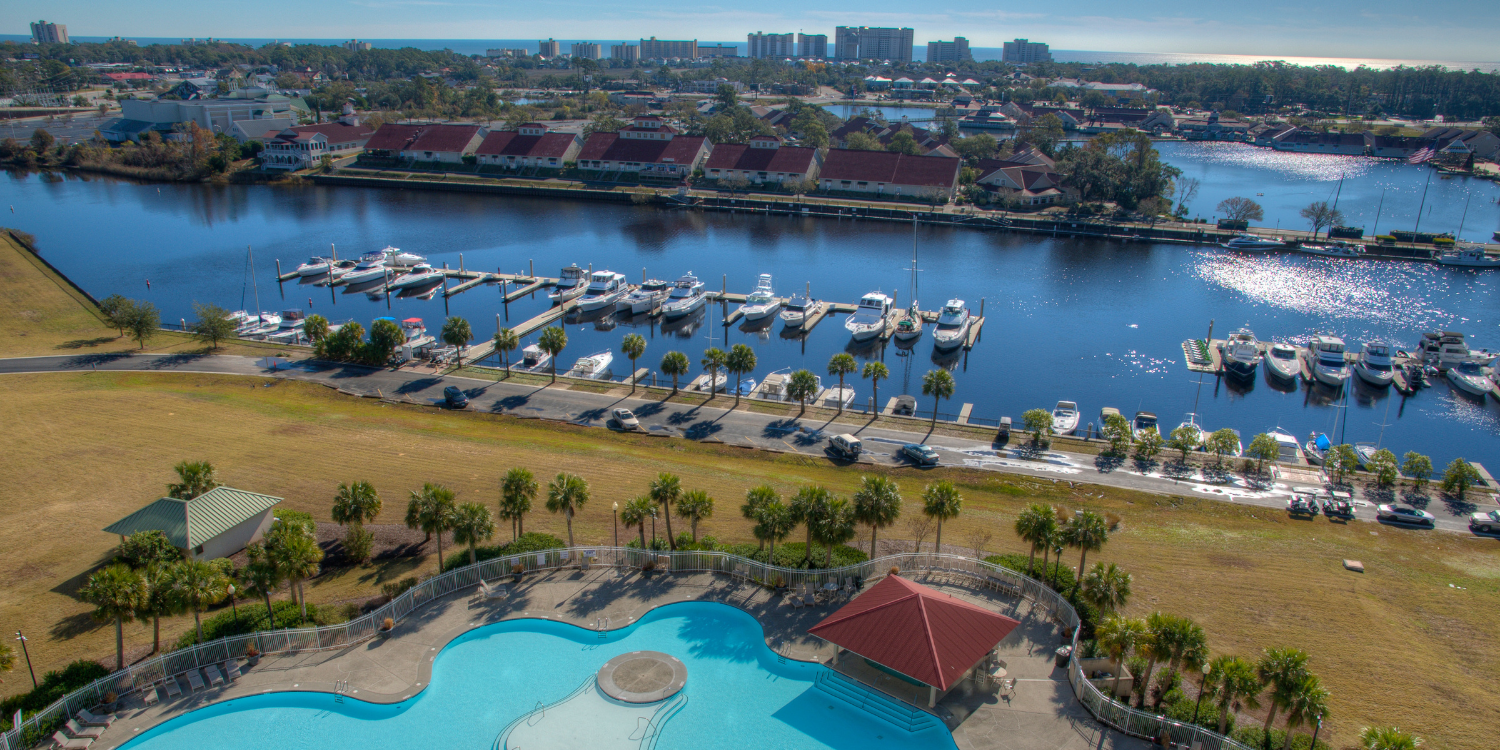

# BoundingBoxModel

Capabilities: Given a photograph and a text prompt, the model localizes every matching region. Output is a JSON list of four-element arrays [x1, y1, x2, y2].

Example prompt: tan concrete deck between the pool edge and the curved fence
[[93, 567, 1148, 750]]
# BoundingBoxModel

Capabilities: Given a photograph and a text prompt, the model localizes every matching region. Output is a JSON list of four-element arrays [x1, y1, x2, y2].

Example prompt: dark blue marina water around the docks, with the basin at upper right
[[0, 144, 1500, 467]]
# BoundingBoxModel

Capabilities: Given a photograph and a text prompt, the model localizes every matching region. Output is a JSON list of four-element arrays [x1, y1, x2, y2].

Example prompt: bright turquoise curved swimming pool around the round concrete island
[[123, 602, 956, 750]]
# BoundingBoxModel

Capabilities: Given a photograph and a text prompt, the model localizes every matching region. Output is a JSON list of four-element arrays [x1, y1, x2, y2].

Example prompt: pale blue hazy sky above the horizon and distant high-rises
[[0, 0, 1500, 60]]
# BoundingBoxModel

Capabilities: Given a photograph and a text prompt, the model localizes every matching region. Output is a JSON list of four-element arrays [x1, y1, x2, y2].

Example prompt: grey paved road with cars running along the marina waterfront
[[0, 353, 1493, 534]]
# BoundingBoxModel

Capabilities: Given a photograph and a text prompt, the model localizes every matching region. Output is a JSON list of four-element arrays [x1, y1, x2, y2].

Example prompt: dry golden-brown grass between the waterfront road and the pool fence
[[0, 228, 1500, 749]]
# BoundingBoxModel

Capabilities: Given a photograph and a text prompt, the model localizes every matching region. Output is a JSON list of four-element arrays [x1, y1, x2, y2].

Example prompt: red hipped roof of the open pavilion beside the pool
[[807, 576, 1020, 690]]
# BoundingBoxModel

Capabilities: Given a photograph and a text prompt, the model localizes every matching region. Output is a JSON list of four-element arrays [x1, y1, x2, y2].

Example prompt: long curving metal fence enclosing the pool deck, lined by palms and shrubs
[[0, 546, 1254, 750]]
